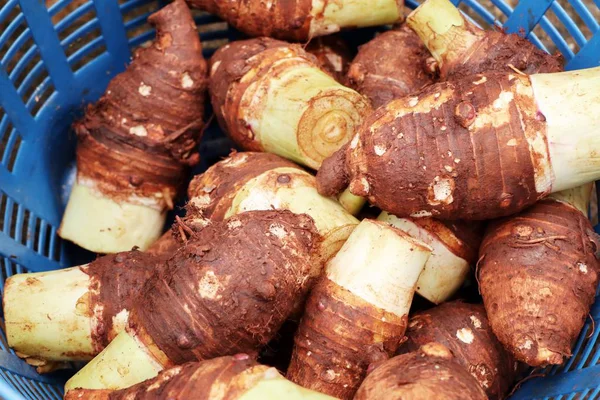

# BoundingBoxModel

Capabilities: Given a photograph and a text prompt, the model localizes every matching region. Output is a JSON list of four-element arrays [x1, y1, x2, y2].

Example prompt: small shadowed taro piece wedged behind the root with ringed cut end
[[306, 35, 352, 84]]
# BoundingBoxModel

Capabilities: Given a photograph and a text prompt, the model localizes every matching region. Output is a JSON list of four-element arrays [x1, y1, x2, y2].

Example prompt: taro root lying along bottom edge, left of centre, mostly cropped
[[65, 354, 333, 400]]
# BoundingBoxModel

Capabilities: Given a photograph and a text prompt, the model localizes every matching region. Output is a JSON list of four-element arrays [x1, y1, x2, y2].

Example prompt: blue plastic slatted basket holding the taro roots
[[0, 0, 600, 400]]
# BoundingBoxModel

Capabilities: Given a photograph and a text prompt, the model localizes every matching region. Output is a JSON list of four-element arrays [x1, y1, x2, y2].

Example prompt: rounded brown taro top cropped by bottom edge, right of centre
[[354, 343, 487, 400]]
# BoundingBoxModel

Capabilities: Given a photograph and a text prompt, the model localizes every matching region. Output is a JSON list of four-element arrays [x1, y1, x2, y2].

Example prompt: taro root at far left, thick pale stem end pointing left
[[3, 251, 164, 368]]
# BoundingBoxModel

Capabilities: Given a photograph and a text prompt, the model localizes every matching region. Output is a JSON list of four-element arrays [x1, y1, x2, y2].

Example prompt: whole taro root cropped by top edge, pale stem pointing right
[[187, 0, 404, 42]]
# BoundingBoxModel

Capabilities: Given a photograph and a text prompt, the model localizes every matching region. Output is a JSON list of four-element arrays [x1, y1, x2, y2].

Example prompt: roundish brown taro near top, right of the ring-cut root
[[348, 25, 435, 108]]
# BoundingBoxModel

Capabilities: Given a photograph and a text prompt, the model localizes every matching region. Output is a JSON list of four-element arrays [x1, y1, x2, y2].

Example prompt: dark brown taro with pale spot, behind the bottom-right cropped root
[[398, 301, 518, 400]]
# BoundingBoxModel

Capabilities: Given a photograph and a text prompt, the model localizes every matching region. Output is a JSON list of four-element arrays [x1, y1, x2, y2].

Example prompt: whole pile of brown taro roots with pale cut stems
[[3, 0, 600, 400]]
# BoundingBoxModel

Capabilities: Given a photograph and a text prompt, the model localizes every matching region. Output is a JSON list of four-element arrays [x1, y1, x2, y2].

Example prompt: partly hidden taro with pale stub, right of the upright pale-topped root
[[377, 212, 483, 304]]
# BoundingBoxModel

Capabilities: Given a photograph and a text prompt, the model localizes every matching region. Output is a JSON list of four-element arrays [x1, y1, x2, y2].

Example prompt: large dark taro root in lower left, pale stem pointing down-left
[[66, 211, 319, 390]]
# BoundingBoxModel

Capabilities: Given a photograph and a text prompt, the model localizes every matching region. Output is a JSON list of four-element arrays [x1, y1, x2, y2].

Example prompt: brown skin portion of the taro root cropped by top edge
[[187, 0, 312, 41]]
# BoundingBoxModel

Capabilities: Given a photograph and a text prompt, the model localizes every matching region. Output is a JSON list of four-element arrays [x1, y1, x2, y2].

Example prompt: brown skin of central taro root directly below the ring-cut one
[[188, 152, 301, 220]]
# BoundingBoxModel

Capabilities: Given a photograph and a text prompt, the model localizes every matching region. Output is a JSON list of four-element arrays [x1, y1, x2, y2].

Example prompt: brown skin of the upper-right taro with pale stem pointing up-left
[[440, 26, 564, 79]]
